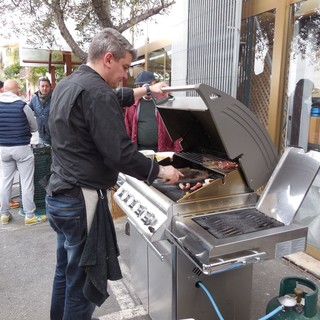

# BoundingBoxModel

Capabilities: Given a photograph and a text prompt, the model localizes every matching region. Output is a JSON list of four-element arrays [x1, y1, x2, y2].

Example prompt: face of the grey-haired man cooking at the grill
[[107, 53, 132, 88]]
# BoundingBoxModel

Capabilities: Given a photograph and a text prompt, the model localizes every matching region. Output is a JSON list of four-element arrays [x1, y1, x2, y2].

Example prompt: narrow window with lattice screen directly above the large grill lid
[[237, 10, 275, 127]]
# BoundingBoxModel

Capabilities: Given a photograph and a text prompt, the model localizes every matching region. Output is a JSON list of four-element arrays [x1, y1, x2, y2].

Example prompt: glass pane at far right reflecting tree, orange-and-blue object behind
[[283, 0, 320, 151]]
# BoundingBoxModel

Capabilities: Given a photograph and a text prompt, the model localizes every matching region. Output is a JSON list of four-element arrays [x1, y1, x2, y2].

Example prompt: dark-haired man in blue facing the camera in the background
[[29, 77, 52, 145]]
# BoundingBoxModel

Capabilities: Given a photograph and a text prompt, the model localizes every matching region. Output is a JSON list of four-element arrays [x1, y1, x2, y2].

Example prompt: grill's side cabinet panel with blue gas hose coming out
[[172, 250, 253, 320]]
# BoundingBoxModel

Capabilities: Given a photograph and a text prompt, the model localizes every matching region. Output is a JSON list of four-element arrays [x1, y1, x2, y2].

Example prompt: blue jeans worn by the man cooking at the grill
[[46, 195, 95, 320]]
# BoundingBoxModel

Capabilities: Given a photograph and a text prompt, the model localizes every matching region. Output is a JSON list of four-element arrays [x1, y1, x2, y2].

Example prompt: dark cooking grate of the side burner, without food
[[193, 208, 284, 239]]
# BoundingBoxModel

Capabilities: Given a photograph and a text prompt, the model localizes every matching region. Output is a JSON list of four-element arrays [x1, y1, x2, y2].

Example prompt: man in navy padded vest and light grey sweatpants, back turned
[[0, 80, 46, 225]]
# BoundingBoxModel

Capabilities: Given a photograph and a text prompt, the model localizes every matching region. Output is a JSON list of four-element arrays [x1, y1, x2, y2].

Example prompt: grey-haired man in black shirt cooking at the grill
[[41, 28, 182, 320]]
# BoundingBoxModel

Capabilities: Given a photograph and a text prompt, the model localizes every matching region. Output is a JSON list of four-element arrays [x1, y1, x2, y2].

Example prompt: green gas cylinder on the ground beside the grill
[[266, 277, 320, 320]]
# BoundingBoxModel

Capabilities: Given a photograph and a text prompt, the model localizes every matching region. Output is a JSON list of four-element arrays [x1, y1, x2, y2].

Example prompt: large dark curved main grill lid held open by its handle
[[155, 84, 278, 190]]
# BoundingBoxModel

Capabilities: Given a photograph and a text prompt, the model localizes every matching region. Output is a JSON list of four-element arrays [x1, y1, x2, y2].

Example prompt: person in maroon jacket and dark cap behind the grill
[[125, 71, 181, 152]]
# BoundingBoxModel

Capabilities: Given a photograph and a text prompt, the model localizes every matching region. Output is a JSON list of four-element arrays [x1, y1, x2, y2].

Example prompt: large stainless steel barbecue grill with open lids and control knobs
[[115, 84, 320, 320]]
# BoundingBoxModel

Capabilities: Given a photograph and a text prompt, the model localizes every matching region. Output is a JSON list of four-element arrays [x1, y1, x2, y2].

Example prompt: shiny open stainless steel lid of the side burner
[[256, 147, 320, 225]]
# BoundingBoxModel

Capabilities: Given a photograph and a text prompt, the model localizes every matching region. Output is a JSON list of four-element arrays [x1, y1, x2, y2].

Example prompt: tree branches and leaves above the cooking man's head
[[0, 0, 175, 61]]
